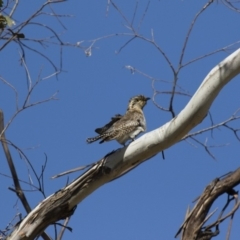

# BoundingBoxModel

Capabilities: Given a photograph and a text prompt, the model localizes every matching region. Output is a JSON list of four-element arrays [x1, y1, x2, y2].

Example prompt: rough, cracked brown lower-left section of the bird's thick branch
[[8, 157, 111, 240]]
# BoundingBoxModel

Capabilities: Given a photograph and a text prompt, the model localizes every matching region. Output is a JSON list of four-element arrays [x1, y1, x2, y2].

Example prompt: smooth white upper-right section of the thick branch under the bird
[[100, 49, 240, 191]]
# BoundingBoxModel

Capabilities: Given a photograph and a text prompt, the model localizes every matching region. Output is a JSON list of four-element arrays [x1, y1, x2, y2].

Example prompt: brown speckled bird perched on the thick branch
[[87, 95, 150, 146]]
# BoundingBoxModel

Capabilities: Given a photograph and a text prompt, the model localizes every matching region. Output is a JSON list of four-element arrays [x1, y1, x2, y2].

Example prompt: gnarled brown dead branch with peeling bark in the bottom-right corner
[[175, 168, 240, 240]]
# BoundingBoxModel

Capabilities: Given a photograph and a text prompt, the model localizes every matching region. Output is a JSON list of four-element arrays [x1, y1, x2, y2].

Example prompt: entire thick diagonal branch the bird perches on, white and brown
[[4, 50, 240, 240]]
